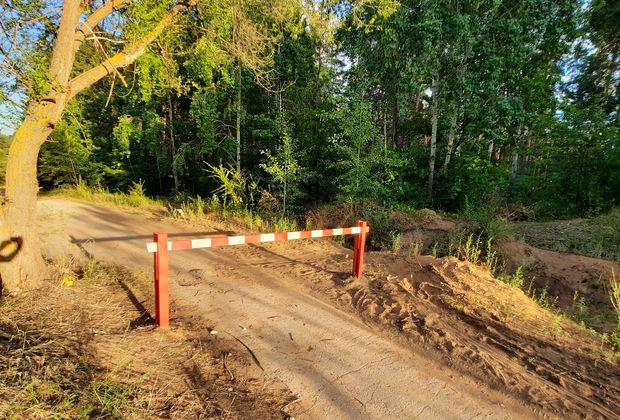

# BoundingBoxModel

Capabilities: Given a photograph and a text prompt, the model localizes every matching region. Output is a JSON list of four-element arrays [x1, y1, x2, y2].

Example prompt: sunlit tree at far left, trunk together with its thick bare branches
[[0, 0, 186, 294]]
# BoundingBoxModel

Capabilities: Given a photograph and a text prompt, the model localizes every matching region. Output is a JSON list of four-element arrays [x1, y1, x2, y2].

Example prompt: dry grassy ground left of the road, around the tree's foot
[[0, 260, 288, 418]]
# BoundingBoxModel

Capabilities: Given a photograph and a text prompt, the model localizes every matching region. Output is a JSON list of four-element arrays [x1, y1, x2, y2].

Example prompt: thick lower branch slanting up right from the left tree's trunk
[[67, 3, 187, 100]]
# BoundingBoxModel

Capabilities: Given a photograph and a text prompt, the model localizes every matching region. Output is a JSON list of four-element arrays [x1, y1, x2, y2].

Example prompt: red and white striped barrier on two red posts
[[146, 220, 370, 327]]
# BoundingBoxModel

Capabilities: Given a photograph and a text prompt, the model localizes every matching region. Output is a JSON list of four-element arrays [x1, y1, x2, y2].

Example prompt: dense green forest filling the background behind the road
[[0, 0, 620, 292]]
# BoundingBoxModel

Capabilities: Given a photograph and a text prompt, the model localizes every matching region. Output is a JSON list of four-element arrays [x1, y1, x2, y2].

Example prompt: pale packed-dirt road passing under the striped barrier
[[39, 199, 532, 419]]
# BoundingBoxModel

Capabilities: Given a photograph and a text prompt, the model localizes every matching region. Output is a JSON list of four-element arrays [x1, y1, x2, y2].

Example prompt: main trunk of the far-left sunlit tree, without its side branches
[[0, 0, 81, 294]]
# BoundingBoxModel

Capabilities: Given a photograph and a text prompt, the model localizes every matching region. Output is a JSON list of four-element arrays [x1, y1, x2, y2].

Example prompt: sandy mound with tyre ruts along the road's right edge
[[339, 254, 620, 418]]
